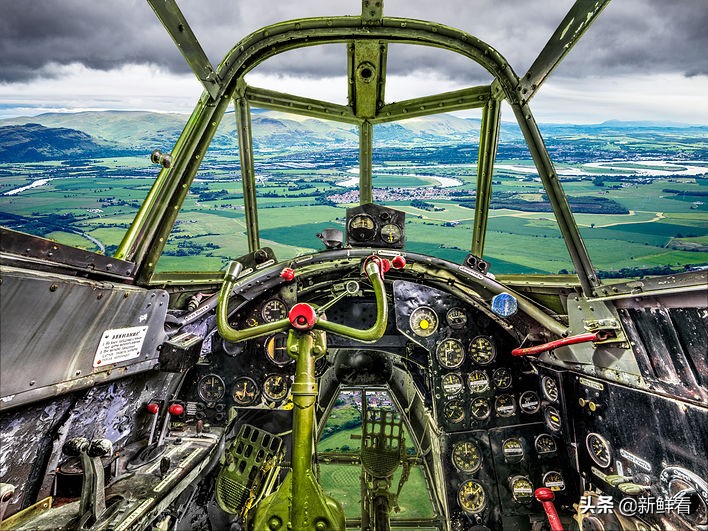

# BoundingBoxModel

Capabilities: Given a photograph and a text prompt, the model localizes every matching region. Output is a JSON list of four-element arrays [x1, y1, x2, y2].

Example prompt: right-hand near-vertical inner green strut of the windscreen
[[472, 98, 501, 257]]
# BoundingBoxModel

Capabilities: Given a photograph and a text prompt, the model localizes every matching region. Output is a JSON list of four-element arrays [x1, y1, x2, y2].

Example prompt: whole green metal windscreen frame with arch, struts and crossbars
[[115, 0, 609, 296]]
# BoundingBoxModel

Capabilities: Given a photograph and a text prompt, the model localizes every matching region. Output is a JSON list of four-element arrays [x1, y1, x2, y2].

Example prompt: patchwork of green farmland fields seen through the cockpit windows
[[0, 151, 708, 273]]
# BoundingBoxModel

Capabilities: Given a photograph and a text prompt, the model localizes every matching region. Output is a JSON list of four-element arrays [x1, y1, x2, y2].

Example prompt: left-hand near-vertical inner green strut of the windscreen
[[235, 96, 261, 253]]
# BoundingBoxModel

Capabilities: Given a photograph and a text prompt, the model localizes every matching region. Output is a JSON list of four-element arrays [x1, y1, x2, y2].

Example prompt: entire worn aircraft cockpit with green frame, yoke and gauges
[[0, 0, 708, 531]]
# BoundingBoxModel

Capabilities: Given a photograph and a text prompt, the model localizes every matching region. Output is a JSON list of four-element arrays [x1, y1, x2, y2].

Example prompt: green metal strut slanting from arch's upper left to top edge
[[147, 0, 221, 100]]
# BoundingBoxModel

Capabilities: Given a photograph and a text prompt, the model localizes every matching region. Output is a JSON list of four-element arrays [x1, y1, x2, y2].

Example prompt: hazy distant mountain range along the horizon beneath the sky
[[0, 110, 708, 162]]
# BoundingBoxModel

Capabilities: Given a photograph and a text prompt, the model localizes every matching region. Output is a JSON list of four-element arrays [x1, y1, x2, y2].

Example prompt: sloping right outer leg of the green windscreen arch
[[511, 104, 599, 297]]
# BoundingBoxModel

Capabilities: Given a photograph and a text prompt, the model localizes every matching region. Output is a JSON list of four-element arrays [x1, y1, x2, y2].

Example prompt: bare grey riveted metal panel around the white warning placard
[[0, 267, 168, 410]]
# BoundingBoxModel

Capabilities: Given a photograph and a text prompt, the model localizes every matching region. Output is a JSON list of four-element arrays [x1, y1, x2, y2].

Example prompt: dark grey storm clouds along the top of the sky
[[0, 0, 708, 82]]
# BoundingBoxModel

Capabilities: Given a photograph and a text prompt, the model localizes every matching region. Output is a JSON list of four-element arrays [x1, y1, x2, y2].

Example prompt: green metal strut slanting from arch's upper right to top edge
[[519, 0, 610, 102]]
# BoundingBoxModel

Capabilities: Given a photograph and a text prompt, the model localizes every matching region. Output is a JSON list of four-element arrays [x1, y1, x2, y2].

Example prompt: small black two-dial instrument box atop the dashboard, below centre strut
[[346, 203, 406, 249]]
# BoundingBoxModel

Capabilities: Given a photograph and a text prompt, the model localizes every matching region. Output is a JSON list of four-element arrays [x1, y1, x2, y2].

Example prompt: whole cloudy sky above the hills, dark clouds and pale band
[[0, 0, 708, 125]]
